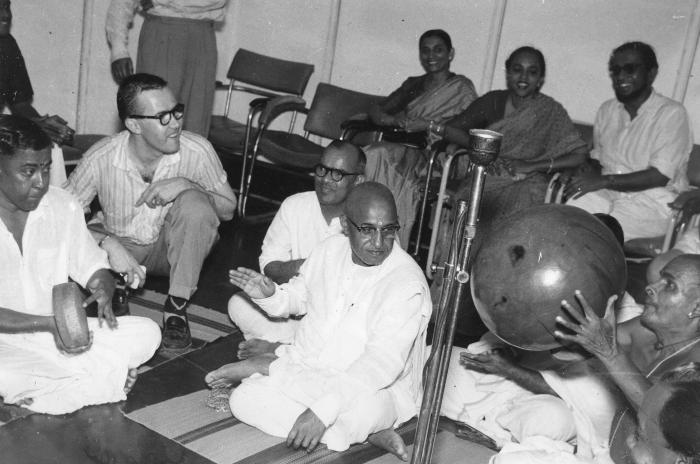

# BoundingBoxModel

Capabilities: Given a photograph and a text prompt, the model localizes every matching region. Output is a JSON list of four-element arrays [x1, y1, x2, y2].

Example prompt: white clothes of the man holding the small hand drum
[[0, 187, 160, 414]]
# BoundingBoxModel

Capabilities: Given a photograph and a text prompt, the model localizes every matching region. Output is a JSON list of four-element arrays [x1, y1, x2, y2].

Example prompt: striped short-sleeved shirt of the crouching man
[[66, 131, 227, 245]]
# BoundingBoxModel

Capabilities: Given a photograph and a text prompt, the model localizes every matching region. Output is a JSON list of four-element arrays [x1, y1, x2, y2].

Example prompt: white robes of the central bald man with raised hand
[[231, 235, 432, 450]]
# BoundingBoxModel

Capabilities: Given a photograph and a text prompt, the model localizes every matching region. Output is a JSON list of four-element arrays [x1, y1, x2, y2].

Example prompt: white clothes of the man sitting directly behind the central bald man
[[228, 191, 342, 343]]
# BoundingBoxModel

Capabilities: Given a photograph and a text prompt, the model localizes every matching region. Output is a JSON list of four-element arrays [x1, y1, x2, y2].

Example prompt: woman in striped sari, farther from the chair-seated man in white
[[365, 29, 476, 247]]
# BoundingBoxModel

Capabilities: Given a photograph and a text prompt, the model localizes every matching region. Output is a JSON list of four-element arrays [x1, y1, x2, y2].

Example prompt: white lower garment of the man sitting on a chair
[[566, 188, 675, 240]]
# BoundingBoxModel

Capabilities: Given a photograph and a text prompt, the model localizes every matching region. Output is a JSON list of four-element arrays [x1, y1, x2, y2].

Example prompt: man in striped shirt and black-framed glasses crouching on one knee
[[67, 74, 236, 350]]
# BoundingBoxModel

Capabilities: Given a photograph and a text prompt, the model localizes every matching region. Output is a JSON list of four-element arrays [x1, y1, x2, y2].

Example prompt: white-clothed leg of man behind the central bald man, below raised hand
[[228, 292, 299, 344]]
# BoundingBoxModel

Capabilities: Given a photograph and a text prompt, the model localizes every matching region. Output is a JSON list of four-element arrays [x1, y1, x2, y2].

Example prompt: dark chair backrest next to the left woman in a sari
[[304, 83, 384, 139]]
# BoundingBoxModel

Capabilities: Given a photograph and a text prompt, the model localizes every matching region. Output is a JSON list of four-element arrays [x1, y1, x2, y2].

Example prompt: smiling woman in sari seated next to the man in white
[[433, 47, 588, 230]]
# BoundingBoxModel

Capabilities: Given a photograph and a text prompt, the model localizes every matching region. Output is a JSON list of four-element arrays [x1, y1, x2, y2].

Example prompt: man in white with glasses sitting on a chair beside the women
[[565, 42, 693, 240]]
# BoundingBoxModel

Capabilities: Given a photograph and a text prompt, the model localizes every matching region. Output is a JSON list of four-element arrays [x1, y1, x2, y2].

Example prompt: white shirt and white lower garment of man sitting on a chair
[[567, 92, 693, 240]]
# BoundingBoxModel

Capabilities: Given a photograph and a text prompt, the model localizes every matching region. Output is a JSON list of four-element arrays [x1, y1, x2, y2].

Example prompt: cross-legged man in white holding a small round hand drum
[[0, 115, 160, 414]]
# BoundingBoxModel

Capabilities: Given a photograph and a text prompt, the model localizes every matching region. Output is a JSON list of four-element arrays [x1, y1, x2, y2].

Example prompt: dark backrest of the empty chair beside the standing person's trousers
[[226, 48, 314, 95]]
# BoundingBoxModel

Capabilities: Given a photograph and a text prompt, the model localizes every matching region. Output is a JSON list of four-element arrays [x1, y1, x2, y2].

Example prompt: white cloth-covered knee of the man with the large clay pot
[[496, 395, 576, 442]]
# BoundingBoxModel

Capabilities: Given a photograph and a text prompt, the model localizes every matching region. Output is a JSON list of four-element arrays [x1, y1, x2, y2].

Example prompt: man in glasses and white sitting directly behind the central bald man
[[228, 140, 366, 359]]
